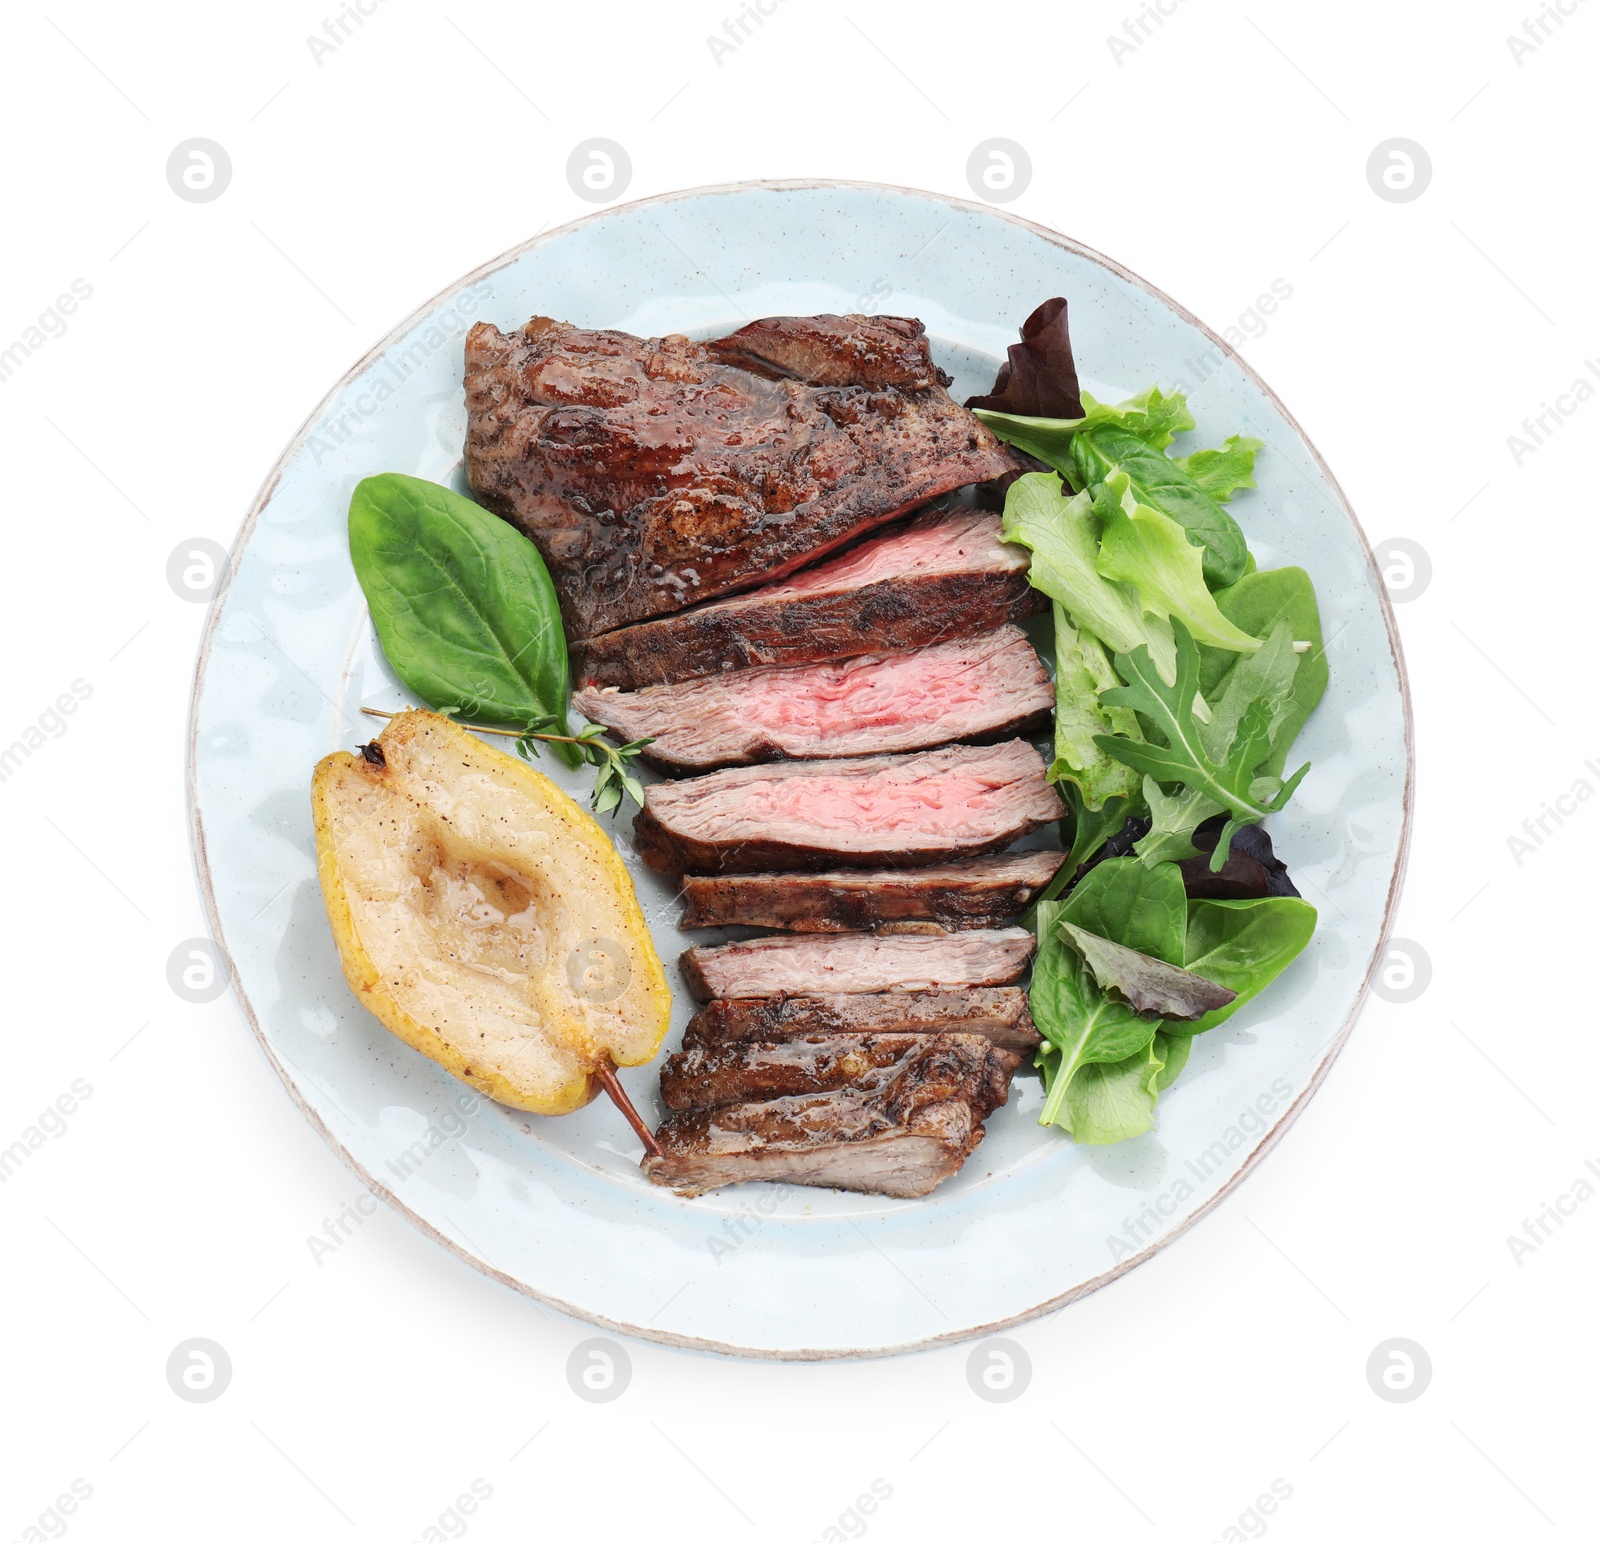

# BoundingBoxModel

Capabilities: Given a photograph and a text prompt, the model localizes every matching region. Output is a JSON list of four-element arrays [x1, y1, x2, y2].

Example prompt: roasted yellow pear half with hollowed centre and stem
[[312, 712, 672, 1114]]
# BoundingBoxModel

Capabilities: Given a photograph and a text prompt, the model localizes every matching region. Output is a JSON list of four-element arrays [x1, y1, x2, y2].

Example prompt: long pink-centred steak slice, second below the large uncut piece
[[573, 626, 1056, 773]]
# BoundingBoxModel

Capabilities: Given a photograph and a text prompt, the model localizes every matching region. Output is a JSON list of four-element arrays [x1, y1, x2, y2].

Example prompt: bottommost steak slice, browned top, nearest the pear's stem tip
[[640, 1036, 1008, 1199]]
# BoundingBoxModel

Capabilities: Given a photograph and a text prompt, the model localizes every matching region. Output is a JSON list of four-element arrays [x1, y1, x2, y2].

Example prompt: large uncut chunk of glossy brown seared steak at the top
[[466, 315, 1016, 639]]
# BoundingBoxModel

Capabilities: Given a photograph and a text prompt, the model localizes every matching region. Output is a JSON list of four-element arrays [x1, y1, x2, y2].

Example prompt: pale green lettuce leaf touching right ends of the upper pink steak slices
[[1000, 472, 1174, 679]]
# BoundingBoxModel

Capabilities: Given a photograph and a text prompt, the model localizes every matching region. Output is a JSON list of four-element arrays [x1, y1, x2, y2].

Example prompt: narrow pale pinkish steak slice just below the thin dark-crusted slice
[[678, 927, 1034, 1002]]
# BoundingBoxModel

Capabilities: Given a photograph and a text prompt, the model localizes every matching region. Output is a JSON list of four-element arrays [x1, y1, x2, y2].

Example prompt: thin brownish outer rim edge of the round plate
[[184, 178, 1416, 1362]]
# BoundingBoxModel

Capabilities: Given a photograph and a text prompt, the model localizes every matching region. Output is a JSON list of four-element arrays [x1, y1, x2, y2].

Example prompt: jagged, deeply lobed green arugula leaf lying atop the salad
[[1096, 623, 1310, 871]]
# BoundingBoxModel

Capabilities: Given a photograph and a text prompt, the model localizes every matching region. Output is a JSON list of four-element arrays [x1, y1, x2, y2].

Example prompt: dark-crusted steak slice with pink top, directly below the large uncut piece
[[573, 507, 1038, 690]]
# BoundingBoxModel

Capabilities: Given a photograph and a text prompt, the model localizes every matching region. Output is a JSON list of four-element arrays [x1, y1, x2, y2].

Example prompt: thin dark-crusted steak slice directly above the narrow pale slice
[[678, 852, 1062, 932]]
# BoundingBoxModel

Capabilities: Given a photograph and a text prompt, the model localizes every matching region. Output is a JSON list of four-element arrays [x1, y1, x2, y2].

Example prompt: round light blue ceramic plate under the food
[[189, 182, 1411, 1359]]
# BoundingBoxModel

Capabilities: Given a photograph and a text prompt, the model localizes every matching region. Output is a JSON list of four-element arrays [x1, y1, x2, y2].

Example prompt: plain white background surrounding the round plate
[[0, 0, 1600, 1543]]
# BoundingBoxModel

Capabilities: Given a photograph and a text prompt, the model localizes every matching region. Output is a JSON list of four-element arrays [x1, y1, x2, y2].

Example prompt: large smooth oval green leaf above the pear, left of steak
[[350, 472, 578, 765]]
